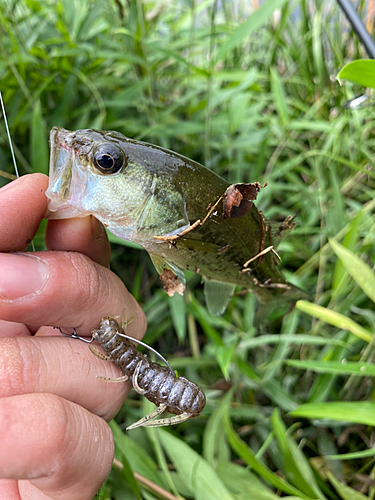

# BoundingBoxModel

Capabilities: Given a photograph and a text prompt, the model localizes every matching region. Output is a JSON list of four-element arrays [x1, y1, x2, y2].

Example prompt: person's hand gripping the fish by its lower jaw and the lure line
[[0, 174, 146, 500]]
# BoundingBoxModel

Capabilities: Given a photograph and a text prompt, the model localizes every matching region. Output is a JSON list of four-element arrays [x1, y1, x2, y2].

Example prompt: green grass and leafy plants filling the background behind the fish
[[0, 0, 375, 500]]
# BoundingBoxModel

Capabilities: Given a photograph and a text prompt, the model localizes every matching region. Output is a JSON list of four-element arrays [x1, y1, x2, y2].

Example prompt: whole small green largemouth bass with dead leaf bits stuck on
[[46, 127, 306, 314]]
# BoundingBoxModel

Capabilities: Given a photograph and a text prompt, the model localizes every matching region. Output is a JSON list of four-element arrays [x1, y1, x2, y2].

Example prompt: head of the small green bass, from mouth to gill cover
[[46, 127, 188, 241]]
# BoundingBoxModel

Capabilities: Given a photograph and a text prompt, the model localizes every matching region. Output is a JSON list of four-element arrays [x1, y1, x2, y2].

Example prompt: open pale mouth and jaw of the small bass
[[46, 127, 89, 219]]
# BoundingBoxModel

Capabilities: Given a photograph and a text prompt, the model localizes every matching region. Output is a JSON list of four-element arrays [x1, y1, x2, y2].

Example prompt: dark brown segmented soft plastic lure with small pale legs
[[92, 317, 206, 428]]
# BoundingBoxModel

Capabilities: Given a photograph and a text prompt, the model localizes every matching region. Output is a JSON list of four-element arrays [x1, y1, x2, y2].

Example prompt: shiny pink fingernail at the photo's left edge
[[0, 253, 50, 300]]
